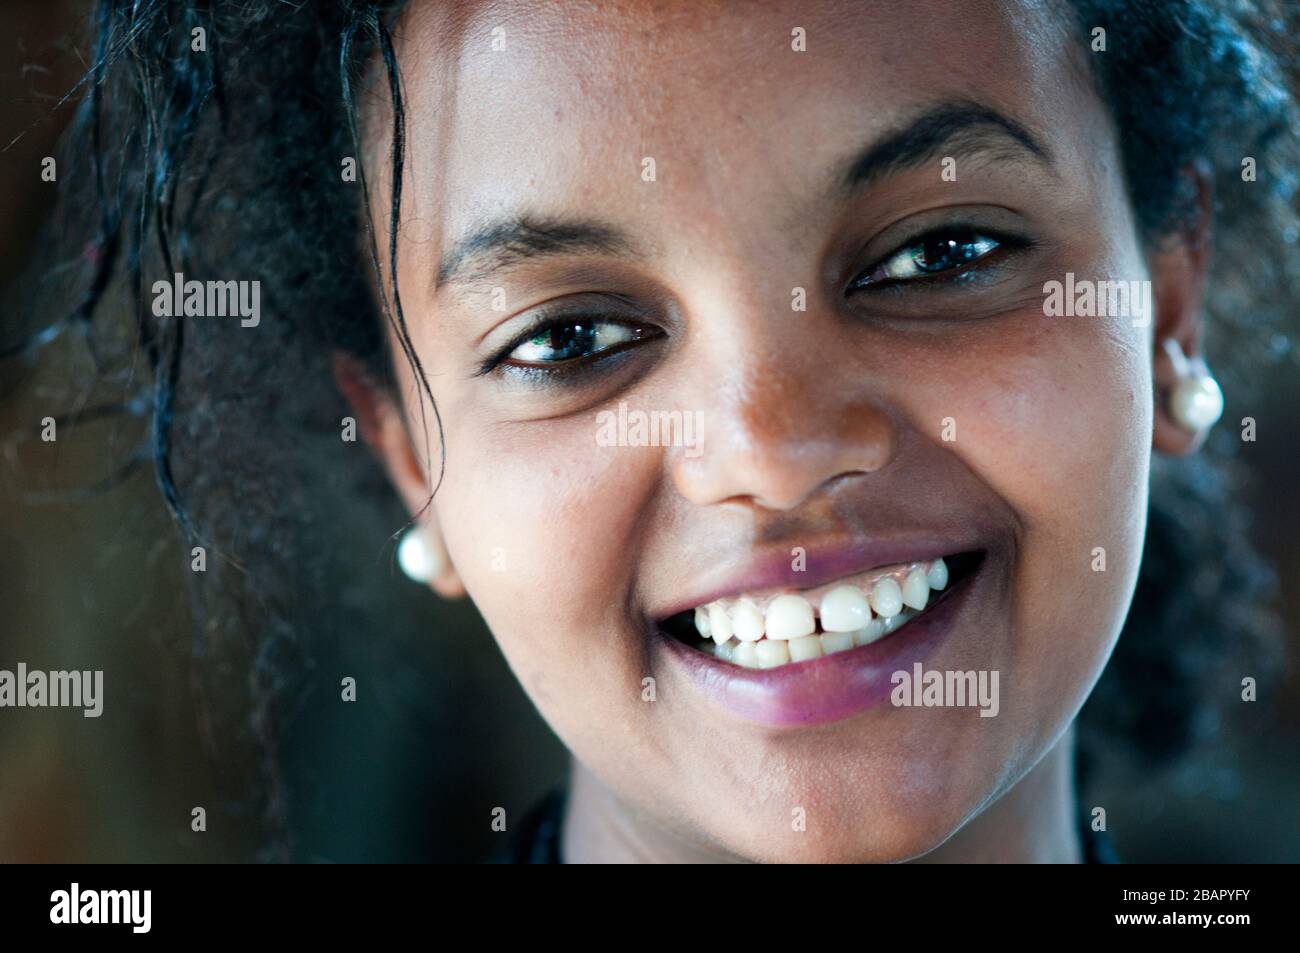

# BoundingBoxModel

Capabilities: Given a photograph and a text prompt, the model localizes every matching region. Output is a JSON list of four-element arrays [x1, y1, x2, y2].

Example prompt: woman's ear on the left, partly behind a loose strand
[[334, 351, 465, 599]]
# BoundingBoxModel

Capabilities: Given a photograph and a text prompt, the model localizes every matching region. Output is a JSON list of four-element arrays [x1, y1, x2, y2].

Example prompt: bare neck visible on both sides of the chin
[[563, 729, 1083, 863]]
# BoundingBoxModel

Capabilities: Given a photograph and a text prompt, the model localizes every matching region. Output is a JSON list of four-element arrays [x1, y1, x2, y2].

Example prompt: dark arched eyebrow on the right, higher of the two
[[837, 100, 1052, 191]]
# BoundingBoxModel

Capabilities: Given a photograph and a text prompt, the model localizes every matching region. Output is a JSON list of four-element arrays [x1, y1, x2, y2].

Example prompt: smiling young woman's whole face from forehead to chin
[[373, 0, 1158, 861]]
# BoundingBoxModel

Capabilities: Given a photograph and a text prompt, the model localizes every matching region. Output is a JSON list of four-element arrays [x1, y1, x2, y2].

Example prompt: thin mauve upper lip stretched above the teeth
[[651, 536, 983, 623]]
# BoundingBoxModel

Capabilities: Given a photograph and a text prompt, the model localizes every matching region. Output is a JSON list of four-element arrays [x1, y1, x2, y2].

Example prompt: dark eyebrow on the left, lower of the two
[[436, 215, 633, 287]]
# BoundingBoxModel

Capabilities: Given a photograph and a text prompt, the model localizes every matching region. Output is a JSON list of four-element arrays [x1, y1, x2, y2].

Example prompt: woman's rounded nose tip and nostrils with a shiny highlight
[[672, 351, 897, 510]]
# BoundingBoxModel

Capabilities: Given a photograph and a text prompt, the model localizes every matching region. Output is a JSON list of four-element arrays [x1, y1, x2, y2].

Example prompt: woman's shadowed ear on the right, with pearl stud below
[[1149, 168, 1213, 456]]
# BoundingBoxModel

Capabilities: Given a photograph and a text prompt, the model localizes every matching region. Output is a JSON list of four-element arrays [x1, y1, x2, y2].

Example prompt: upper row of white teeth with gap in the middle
[[696, 559, 948, 645]]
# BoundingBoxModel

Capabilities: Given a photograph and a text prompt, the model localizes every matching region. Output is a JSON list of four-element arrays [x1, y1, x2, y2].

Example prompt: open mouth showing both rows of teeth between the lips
[[662, 553, 984, 668]]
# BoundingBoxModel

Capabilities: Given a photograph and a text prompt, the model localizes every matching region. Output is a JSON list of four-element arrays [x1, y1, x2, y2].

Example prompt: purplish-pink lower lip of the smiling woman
[[657, 560, 987, 728]]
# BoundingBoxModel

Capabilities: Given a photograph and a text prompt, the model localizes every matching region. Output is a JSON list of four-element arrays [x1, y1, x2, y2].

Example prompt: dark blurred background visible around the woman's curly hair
[[0, 0, 1300, 862]]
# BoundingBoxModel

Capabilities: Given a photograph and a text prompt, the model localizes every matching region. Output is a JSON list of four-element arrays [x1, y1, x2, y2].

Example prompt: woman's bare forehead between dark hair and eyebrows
[[398, 0, 1084, 263]]
